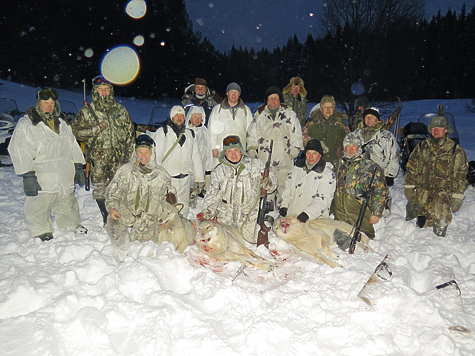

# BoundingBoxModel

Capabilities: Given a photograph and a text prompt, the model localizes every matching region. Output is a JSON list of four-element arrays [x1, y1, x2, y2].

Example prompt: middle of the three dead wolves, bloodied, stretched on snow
[[195, 220, 275, 271]]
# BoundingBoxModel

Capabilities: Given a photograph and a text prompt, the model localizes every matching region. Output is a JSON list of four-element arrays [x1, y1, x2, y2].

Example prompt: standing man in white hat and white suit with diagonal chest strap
[[152, 105, 204, 218]]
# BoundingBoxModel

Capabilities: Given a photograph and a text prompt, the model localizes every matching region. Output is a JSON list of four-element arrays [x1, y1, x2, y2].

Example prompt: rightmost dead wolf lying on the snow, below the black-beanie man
[[273, 216, 371, 267]]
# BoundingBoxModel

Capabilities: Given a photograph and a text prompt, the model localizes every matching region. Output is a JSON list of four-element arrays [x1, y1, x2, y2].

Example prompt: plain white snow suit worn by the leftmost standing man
[[8, 108, 85, 237]]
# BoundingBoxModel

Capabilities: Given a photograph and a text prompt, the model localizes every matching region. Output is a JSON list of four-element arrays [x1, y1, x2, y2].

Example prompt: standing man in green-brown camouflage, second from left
[[72, 76, 135, 224]]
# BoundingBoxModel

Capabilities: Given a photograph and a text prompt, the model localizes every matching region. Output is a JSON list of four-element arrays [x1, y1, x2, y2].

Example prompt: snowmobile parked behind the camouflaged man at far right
[[399, 105, 460, 172]]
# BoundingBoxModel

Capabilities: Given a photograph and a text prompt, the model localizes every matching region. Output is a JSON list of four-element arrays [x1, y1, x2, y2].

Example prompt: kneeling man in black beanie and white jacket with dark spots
[[279, 139, 336, 223]]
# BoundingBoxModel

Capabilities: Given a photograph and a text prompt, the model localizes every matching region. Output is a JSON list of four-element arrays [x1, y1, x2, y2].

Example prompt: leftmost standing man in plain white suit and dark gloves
[[8, 89, 87, 241]]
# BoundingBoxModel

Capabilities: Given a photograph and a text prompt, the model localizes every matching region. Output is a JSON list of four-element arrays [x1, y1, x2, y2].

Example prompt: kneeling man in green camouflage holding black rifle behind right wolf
[[333, 132, 389, 239]]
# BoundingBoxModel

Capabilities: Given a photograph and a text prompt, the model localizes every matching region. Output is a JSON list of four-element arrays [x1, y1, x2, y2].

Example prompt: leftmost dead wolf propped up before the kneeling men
[[156, 201, 196, 253]]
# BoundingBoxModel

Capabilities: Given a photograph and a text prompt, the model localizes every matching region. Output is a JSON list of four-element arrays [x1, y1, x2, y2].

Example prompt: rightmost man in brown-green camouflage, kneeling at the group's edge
[[404, 116, 468, 236]]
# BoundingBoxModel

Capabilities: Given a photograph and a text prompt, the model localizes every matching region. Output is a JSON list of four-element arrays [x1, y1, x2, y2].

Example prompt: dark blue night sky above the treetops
[[185, 0, 475, 51]]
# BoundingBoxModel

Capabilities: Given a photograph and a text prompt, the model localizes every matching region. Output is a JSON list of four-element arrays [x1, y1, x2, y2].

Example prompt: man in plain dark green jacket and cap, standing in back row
[[302, 95, 350, 167]]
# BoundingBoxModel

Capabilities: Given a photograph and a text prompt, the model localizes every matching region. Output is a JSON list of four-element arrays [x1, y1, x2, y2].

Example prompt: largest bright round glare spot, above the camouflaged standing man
[[101, 46, 140, 84]]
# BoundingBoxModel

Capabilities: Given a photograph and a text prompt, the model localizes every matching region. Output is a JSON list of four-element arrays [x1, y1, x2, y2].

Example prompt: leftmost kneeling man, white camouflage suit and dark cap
[[106, 134, 176, 248]]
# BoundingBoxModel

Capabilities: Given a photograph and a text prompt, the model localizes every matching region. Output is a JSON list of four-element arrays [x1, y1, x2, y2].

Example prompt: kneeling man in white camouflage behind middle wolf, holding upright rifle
[[196, 136, 277, 243]]
